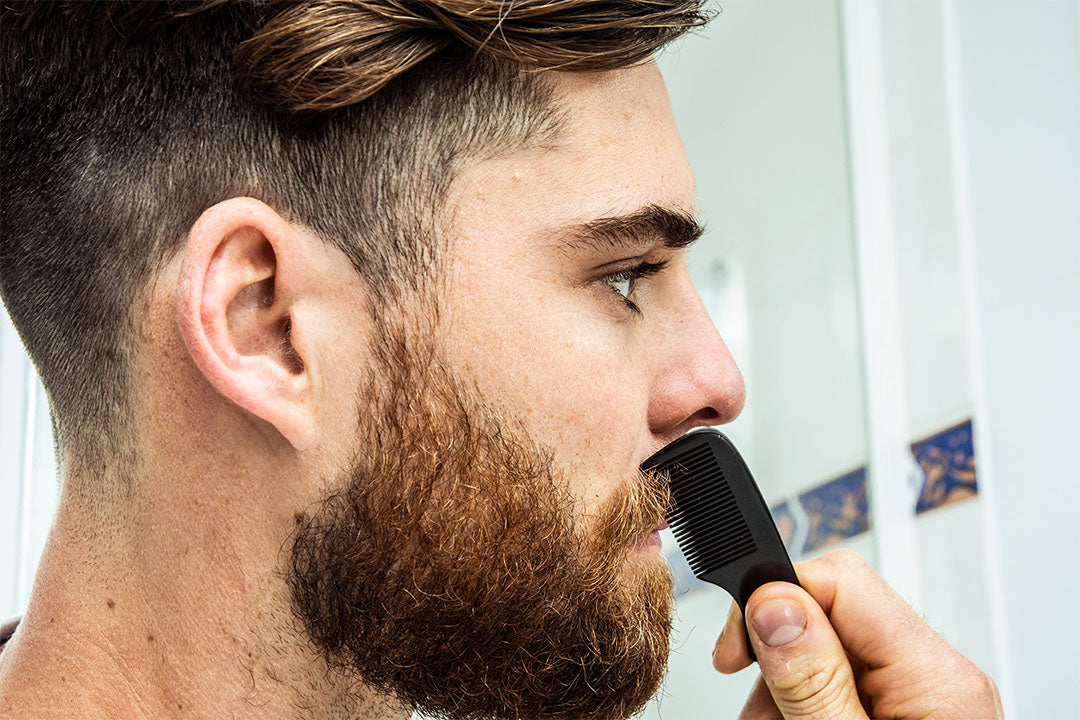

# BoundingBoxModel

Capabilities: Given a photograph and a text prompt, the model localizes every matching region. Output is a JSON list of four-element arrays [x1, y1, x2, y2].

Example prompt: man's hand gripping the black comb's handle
[[713, 551, 1004, 720]]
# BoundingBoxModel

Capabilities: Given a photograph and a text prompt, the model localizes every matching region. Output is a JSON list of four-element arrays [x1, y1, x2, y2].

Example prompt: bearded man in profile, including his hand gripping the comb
[[0, 0, 1000, 718]]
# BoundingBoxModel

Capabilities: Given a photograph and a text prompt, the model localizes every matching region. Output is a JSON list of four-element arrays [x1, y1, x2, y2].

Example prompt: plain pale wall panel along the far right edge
[[946, 0, 1080, 719]]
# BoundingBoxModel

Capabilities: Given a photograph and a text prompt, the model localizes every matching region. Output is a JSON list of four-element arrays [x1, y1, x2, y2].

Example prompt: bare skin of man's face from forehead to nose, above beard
[[443, 64, 744, 533]]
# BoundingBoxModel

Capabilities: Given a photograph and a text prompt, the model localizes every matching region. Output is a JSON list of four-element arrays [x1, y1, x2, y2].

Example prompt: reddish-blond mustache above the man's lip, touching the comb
[[593, 470, 671, 549]]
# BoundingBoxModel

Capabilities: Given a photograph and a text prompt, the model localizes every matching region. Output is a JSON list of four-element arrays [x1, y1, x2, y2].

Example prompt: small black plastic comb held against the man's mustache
[[642, 427, 799, 660]]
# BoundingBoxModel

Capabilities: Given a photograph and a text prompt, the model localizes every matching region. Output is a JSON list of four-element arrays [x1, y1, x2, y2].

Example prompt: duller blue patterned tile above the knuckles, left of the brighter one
[[799, 467, 870, 553]]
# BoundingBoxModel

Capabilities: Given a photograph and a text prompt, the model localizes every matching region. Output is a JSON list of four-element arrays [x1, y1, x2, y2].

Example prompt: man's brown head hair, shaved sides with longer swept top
[[0, 0, 705, 483]]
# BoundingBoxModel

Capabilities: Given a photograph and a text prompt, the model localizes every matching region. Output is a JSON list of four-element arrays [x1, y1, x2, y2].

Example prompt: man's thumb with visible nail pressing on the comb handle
[[746, 583, 867, 720]]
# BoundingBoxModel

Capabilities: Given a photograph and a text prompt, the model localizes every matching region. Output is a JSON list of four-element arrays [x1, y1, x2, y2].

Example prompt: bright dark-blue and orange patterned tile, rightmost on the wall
[[912, 420, 978, 513]]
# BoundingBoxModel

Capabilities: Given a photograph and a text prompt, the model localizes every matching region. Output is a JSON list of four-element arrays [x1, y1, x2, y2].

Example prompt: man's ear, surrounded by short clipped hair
[[176, 198, 314, 450]]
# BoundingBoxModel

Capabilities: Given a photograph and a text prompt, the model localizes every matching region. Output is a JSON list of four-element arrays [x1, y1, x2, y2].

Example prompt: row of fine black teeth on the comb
[[662, 445, 757, 578]]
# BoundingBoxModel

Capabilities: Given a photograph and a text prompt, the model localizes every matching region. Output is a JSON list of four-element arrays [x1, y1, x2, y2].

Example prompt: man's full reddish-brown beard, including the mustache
[[287, 330, 673, 720]]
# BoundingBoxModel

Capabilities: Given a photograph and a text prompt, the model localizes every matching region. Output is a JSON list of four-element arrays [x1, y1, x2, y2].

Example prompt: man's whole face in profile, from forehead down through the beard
[[289, 66, 742, 718]]
